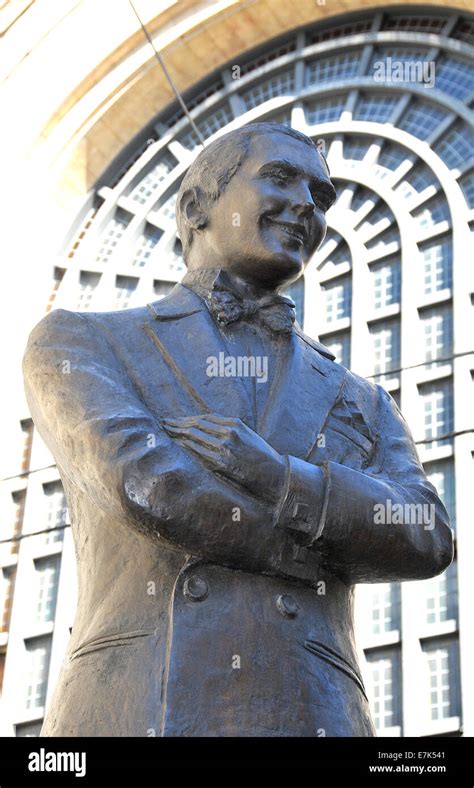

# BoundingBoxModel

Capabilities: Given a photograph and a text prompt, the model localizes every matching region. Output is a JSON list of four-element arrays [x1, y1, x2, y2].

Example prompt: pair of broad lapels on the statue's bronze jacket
[[144, 285, 346, 460]]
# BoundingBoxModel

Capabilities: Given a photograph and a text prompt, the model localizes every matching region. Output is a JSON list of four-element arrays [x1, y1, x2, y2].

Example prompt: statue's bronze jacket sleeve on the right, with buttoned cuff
[[279, 386, 453, 583]]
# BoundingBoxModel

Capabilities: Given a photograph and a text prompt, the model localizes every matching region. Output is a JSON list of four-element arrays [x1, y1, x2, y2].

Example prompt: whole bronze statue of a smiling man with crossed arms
[[24, 123, 452, 736]]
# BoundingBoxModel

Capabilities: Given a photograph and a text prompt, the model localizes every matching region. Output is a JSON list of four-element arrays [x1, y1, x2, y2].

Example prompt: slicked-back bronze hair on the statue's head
[[176, 123, 329, 262]]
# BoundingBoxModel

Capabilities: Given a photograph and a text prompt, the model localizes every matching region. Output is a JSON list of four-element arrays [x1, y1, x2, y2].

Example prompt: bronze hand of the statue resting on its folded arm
[[162, 413, 286, 503]]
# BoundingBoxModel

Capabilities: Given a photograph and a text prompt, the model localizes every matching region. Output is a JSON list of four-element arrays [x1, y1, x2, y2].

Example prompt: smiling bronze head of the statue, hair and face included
[[176, 123, 336, 286]]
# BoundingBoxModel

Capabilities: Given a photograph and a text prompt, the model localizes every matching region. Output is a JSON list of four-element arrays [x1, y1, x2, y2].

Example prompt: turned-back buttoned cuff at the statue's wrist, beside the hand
[[275, 455, 331, 547]]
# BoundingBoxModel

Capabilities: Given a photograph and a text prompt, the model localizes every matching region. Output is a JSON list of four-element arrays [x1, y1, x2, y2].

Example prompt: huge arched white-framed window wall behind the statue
[[0, 2, 474, 736]]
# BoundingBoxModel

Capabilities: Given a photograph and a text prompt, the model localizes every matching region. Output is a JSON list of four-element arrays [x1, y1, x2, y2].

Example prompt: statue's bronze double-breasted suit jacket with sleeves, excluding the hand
[[24, 285, 452, 736]]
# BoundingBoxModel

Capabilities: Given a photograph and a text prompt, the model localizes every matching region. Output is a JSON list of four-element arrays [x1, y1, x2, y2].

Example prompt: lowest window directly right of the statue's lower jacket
[[366, 649, 401, 731]]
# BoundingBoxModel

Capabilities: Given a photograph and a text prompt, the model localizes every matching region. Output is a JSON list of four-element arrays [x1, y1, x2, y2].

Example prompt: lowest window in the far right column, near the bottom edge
[[423, 640, 461, 720]]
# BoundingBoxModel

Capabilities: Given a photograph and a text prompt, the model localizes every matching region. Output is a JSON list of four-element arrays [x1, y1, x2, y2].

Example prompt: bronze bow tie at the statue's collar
[[206, 289, 295, 334]]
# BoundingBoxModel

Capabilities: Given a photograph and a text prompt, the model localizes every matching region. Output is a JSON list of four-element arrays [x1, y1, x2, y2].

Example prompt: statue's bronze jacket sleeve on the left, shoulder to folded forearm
[[23, 310, 292, 574]]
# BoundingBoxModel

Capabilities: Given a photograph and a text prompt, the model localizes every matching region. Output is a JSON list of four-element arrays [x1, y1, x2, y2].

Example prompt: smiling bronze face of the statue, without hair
[[205, 132, 334, 286]]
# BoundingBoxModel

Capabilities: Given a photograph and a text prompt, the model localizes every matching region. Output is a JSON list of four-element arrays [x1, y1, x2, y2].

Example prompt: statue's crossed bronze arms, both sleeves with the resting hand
[[24, 310, 452, 583]]
